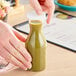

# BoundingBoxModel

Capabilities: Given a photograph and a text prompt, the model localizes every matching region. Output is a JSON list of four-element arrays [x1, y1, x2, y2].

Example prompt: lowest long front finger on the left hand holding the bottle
[[0, 44, 27, 70]]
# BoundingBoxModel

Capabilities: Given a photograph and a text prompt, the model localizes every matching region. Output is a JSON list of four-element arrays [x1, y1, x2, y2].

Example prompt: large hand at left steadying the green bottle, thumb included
[[0, 21, 31, 70]]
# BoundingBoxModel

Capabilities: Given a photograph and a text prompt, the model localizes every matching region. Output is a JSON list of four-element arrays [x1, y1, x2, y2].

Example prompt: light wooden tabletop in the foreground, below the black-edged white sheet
[[0, 4, 76, 76]]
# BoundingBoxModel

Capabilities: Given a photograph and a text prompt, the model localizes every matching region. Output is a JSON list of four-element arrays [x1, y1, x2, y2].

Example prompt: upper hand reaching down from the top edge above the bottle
[[30, 0, 55, 24]]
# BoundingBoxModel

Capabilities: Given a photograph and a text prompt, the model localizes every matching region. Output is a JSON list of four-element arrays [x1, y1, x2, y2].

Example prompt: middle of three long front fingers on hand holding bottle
[[5, 44, 31, 68]]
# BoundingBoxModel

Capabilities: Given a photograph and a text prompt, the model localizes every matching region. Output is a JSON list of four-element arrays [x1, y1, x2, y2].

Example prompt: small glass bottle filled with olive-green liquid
[[25, 20, 46, 71]]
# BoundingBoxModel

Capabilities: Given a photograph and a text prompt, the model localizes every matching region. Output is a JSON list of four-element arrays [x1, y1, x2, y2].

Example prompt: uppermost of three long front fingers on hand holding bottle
[[10, 38, 32, 62]]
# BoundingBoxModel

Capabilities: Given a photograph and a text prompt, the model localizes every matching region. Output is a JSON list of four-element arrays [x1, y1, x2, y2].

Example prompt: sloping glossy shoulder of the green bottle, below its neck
[[26, 33, 46, 47]]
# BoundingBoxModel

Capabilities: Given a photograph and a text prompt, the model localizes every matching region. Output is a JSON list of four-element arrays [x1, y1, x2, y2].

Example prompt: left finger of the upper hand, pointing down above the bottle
[[30, 0, 43, 15]]
